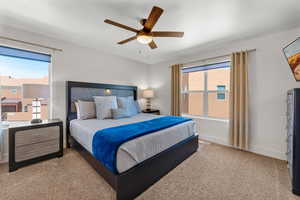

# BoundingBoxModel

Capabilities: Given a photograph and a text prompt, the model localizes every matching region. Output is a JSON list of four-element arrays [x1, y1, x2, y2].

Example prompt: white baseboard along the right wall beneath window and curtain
[[199, 135, 287, 160]]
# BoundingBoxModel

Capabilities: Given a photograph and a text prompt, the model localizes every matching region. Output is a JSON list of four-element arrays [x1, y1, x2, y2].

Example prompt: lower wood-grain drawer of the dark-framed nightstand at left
[[15, 139, 60, 162]]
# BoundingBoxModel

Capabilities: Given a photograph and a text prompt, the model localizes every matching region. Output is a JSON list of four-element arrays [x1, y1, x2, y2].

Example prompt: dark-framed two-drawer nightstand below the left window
[[8, 120, 63, 172]]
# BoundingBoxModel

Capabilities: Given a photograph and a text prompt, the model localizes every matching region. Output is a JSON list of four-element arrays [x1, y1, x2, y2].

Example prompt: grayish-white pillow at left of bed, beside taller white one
[[75, 100, 96, 120]]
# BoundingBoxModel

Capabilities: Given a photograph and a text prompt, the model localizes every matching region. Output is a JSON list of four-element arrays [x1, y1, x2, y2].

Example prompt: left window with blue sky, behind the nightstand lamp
[[0, 46, 51, 121]]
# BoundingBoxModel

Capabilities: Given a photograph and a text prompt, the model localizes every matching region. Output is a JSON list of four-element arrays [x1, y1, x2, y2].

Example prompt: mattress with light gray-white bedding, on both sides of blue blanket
[[70, 113, 195, 173]]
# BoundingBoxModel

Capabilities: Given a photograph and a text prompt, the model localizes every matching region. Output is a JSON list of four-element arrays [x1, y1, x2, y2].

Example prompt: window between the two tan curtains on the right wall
[[181, 62, 230, 119]]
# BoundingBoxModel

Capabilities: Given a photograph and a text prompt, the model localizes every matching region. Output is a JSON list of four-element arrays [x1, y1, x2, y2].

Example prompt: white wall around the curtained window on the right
[[149, 28, 300, 159]]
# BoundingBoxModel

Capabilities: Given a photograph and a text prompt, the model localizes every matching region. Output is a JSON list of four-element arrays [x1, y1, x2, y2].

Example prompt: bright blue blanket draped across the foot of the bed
[[92, 116, 192, 173]]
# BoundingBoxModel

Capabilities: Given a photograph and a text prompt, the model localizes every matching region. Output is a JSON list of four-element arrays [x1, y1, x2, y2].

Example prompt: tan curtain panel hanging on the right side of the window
[[229, 51, 248, 150]]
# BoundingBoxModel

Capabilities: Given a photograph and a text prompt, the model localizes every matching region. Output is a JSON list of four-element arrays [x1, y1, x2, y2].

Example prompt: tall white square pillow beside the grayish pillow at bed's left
[[94, 96, 118, 120]]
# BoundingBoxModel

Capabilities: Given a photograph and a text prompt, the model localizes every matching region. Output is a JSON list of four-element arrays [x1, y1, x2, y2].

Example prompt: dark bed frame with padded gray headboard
[[66, 81, 198, 200]]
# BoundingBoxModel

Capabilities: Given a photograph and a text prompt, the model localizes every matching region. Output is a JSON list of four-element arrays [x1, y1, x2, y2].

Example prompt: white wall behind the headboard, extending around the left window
[[0, 26, 148, 162]]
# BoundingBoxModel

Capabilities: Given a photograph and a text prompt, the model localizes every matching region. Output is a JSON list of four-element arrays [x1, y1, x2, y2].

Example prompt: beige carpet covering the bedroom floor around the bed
[[0, 144, 300, 200]]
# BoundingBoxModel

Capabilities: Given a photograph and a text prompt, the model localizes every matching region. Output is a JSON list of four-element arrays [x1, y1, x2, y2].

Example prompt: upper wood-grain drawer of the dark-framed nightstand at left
[[15, 126, 59, 147]]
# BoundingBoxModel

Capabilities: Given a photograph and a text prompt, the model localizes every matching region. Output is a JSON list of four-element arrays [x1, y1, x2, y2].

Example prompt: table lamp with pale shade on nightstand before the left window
[[22, 84, 49, 124]]
